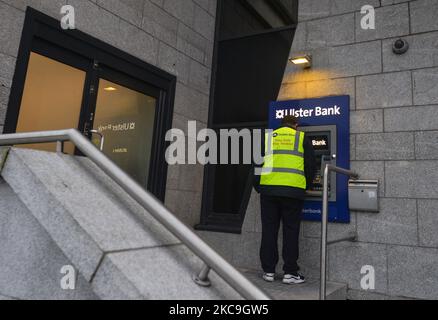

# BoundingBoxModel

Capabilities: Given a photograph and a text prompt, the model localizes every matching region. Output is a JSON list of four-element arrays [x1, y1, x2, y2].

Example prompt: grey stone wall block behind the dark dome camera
[[382, 32, 438, 72]]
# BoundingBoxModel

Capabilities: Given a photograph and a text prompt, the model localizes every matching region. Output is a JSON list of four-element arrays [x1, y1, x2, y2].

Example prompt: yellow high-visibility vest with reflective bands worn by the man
[[260, 127, 307, 189]]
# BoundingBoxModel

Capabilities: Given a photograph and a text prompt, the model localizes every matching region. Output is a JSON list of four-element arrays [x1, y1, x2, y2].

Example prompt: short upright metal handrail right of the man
[[319, 164, 359, 300]]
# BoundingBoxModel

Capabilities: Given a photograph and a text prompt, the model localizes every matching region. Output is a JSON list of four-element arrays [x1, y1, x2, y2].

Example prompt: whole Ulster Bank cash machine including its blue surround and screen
[[269, 96, 350, 223]]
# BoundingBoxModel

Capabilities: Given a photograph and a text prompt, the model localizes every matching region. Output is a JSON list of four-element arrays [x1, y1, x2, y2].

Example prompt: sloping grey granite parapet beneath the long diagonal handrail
[[0, 148, 241, 300]]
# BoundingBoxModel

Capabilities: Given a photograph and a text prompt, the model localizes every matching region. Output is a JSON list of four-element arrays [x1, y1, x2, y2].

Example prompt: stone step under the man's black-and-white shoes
[[241, 269, 347, 300]]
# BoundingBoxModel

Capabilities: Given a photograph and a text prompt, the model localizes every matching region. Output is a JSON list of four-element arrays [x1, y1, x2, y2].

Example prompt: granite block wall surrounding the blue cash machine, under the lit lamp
[[203, 0, 438, 299]]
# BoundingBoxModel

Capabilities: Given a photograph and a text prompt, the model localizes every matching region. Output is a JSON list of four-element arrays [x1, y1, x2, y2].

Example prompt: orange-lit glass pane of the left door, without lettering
[[16, 52, 86, 154]]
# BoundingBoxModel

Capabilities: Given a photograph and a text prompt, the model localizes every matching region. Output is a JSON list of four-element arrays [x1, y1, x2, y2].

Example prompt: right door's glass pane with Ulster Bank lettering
[[93, 79, 157, 186]]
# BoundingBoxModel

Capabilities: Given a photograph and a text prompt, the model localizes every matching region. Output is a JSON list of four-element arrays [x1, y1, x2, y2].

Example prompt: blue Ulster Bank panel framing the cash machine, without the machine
[[269, 96, 350, 223]]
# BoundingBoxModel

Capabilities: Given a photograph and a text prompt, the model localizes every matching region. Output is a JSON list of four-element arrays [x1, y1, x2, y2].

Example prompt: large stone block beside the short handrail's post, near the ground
[[329, 243, 387, 293]]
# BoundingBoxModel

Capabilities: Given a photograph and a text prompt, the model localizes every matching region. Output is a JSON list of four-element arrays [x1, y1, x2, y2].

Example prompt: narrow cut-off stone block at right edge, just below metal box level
[[418, 200, 438, 248]]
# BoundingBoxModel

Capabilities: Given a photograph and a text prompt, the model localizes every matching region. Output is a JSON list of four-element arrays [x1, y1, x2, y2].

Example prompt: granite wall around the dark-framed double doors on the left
[[0, 0, 216, 225]]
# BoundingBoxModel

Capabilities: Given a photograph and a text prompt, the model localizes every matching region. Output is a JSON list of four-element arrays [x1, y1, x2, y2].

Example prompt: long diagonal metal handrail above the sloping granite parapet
[[0, 129, 270, 300]]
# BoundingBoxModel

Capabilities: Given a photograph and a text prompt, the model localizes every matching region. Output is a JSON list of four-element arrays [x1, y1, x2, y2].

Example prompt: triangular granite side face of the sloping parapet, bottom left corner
[[0, 181, 97, 300]]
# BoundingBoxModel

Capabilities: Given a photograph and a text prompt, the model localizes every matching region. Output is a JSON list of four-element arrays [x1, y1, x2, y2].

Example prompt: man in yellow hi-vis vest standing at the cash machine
[[255, 116, 315, 284]]
